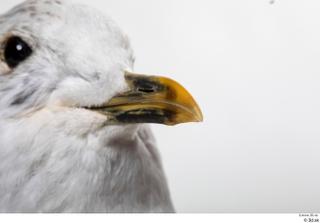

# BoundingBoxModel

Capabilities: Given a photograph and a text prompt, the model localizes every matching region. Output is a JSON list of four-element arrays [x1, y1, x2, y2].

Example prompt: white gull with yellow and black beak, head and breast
[[0, 0, 203, 212]]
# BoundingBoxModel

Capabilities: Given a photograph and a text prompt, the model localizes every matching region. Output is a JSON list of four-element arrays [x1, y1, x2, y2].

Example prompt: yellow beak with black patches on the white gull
[[87, 72, 203, 126]]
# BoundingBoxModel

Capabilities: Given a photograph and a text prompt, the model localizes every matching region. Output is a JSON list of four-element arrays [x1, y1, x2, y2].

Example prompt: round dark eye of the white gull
[[4, 37, 32, 68]]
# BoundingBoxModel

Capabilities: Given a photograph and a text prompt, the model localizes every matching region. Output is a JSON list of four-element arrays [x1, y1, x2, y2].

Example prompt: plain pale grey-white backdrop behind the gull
[[0, 0, 320, 213]]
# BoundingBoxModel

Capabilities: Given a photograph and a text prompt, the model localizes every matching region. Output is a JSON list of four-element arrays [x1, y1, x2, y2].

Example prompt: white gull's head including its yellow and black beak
[[0, 0, 202, 139]]
